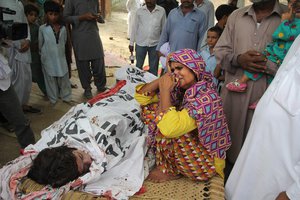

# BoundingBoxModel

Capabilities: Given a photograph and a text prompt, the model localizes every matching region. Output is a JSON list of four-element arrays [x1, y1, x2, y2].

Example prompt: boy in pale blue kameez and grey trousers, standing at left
[[39, 1, 71, 104]]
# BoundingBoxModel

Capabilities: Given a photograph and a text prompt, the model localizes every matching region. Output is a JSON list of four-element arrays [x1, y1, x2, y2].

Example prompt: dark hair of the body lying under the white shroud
[[27, 146, 79, 187]]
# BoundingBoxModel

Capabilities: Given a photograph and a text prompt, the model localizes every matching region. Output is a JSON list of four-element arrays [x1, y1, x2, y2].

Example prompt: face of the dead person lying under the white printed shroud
[[73, 150, 92, 175]]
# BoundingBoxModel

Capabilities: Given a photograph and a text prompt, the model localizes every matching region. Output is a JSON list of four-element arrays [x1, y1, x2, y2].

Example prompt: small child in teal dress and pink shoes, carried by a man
[[226, 0, 300, 93]]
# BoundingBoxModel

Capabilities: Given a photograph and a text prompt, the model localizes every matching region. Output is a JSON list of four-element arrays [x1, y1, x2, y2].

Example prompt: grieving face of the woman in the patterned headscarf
[[171, 62, 196, 89]]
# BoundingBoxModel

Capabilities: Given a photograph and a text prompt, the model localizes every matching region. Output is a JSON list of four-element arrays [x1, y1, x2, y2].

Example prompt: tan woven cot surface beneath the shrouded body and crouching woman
[[20, 176, 224, 200]]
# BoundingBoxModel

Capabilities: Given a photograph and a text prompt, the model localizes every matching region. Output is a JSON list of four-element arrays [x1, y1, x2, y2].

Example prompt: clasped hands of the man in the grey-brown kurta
[[237, 50, 267, 73]]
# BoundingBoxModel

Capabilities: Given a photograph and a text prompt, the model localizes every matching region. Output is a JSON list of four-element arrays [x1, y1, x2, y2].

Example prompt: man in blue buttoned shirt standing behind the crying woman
[[156, 0, 207, 53]]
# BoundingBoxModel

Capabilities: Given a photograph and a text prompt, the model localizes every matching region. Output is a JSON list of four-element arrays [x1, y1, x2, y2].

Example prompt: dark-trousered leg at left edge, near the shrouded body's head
[[0, 86, 35, 148]]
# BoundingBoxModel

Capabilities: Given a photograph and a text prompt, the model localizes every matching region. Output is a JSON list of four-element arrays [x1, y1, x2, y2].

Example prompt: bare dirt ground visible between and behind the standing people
[[0, 0, 247, 167]]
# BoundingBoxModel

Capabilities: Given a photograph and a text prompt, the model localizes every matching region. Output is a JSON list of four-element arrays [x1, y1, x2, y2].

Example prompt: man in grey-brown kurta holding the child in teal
[[214, 0, 286, 179]]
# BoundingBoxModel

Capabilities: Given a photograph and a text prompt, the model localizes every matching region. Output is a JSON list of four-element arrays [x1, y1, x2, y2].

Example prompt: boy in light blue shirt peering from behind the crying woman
[[200, 26, 222, 89]]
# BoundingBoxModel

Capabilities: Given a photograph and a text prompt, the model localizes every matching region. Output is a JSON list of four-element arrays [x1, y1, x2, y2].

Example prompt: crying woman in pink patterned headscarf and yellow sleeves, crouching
[[135, 49, 231, 182]]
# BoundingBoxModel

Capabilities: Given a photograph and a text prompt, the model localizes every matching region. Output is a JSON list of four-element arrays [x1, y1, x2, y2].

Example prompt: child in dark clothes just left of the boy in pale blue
[[24, 4, 47, 96]]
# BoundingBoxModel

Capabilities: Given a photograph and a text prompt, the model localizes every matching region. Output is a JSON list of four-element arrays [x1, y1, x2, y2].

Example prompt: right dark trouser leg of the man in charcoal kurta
[[91, 57, 106, 92]]
